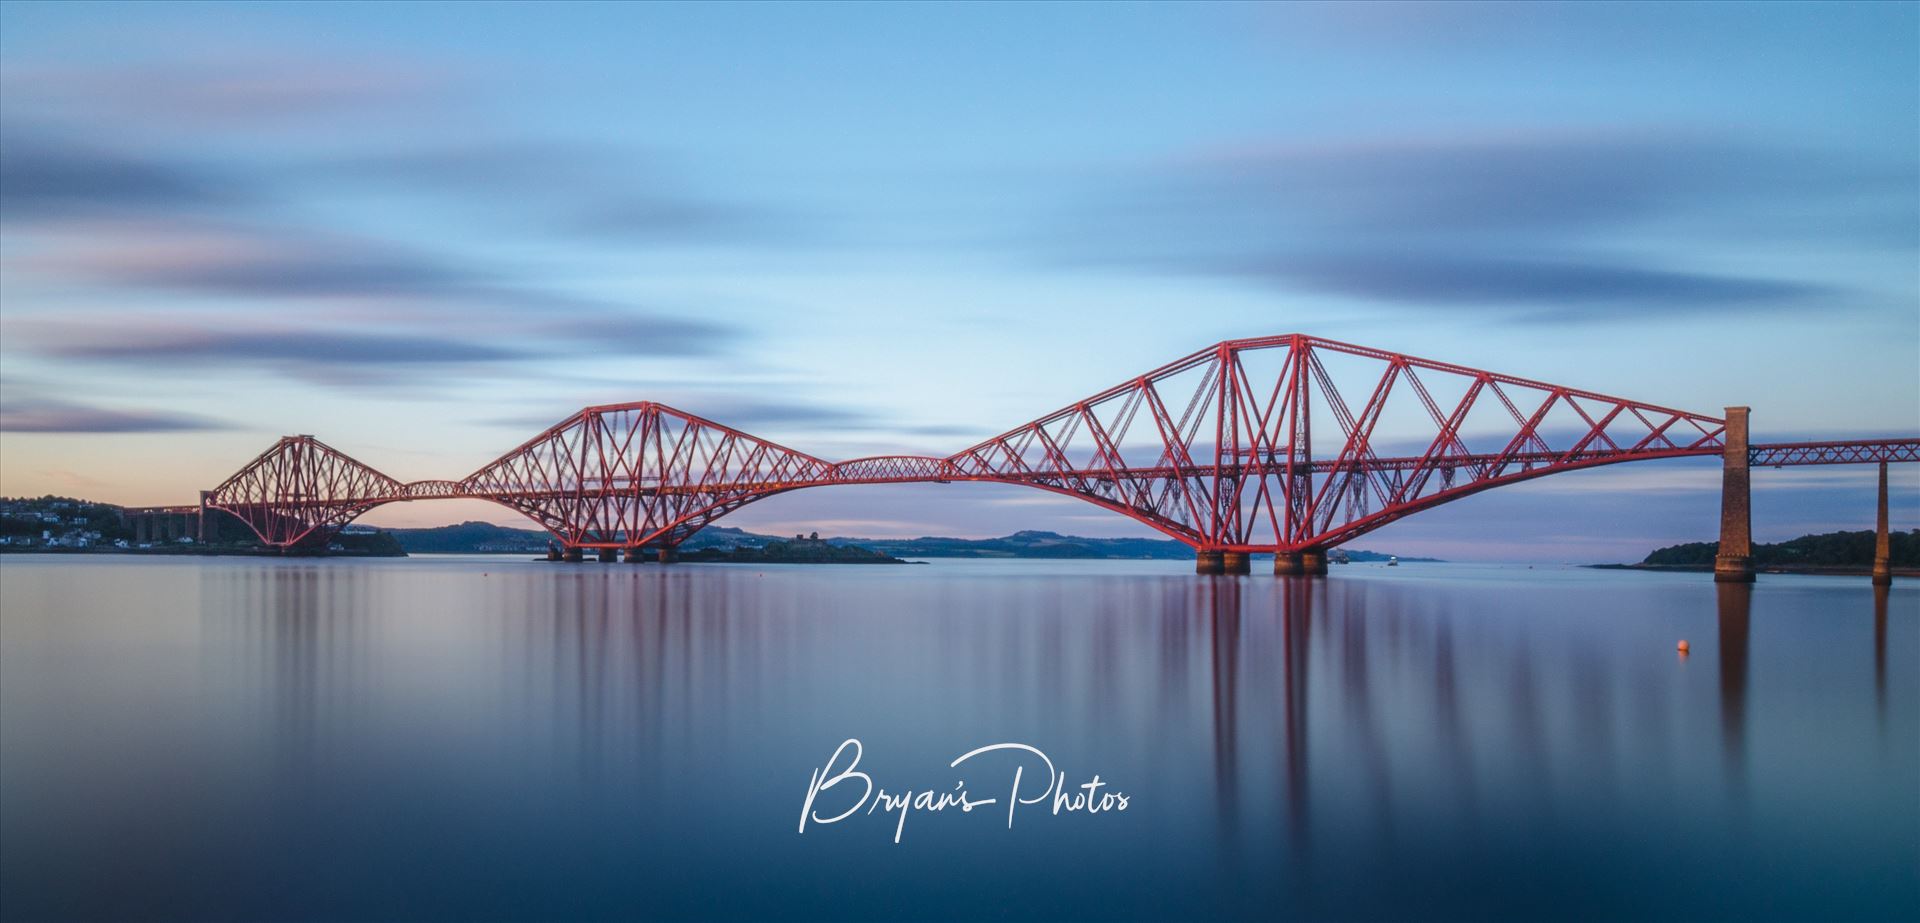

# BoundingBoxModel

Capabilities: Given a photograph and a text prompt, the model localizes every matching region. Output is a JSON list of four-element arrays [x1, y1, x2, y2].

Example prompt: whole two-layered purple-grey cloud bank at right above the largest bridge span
[[1054, 127, 1920, 322]]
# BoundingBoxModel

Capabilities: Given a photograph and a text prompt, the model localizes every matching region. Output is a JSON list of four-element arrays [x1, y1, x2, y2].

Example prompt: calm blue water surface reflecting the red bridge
[[0, 556, 1920, 921]]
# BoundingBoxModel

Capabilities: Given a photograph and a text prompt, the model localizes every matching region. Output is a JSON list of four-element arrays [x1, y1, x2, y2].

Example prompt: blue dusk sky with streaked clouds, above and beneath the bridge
[[0, 0, 1920, 560]]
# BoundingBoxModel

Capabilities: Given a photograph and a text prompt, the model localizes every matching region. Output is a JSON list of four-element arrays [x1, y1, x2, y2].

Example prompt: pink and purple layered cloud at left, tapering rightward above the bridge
[[6, 219, 739, 386]]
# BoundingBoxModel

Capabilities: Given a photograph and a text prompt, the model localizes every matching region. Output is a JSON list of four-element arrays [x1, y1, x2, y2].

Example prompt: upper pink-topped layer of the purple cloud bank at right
[[1171, 125, 1920, 244]]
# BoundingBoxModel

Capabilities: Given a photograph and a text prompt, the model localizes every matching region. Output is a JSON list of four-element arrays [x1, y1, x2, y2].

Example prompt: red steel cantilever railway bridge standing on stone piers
[[134, 334, 1920, 581]]
